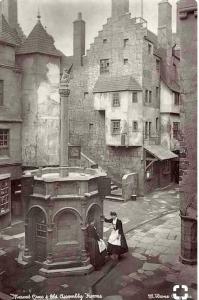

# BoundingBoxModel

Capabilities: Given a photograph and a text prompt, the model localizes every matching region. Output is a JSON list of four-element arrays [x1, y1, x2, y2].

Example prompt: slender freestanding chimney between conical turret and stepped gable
[[73, 12, 86, 67]]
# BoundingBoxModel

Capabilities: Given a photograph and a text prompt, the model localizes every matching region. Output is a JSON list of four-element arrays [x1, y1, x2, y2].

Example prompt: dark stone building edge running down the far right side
[[177, 0, 197, 264]]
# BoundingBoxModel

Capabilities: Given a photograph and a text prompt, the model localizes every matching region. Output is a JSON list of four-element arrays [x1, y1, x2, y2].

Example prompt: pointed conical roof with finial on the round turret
[[17, 20, 61, 57]]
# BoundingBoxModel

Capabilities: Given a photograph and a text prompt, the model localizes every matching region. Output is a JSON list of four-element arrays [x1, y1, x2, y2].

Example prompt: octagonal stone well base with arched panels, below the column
[[22, 167, 110, 276]]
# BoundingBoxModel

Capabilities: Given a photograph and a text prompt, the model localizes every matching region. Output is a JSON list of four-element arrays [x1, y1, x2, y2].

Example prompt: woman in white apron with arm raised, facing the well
[[104, 212, 128, 258]]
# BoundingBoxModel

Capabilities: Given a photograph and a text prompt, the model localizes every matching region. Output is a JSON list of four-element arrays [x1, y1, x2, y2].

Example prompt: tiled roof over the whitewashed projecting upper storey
[[93, 75, 142, 93]]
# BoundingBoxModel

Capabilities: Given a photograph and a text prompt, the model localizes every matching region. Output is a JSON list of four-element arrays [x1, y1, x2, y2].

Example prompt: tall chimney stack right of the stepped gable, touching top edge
[[158, 0, 172, 49]]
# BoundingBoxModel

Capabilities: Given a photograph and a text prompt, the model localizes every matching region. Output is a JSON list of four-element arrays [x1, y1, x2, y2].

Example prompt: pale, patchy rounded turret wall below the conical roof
[[17, 54, 60, 167]]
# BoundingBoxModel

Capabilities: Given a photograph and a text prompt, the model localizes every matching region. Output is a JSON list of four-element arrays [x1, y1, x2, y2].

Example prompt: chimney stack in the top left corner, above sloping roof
[[1, 0, 18, 28]]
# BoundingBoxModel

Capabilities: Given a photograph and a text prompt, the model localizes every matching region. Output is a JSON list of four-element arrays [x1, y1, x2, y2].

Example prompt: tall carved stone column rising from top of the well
[[59, 70, 70, 177]]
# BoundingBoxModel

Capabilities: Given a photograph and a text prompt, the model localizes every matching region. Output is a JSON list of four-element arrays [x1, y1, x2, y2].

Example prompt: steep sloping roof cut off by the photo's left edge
[[0, 15, 17, 46]]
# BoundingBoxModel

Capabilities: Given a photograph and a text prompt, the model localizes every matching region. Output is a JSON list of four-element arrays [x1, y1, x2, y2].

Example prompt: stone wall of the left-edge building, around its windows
[[0, 45, 22, 179]]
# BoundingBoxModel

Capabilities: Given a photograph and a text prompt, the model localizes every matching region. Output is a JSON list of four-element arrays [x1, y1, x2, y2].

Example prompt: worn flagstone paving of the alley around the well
[[0, 188, 196, 300]]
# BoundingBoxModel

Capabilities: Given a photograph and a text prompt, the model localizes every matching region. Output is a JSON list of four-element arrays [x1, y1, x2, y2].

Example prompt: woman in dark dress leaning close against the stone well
[[87, 220, 107, 270]]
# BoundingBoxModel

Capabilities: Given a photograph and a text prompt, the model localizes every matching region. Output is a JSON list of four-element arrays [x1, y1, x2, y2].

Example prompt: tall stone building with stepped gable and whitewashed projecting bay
[[70, 0, 180, 195]]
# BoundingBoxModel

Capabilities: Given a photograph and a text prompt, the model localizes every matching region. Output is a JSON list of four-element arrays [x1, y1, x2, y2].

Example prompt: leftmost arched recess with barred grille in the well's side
[[28, 207, 47, 261]]
